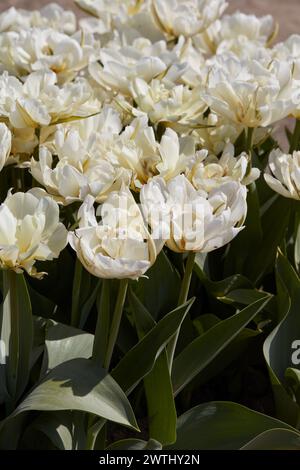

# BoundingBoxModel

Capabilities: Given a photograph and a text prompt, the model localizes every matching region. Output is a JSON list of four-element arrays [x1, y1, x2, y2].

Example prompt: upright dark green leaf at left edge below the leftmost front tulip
[[0, 270, 33, 403]]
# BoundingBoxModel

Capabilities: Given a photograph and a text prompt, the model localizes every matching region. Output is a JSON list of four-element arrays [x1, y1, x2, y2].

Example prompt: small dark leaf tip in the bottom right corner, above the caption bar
[[241, 429, 300, 450]]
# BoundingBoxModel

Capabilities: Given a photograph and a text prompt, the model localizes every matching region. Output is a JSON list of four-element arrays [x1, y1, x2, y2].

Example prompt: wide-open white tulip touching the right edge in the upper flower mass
[[204, 55, 300, 128]]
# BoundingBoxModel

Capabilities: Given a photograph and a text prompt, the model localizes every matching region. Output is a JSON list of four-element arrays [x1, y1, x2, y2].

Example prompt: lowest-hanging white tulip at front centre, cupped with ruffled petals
[[69, 188, 157, 279]]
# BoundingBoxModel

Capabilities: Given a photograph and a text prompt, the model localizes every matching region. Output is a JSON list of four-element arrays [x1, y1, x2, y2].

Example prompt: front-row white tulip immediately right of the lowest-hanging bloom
[[141, 175, 247, 253]]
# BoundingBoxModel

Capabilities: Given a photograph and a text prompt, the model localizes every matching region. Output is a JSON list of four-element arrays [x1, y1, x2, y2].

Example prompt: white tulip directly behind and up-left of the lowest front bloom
[[30, 108, 131, 205]]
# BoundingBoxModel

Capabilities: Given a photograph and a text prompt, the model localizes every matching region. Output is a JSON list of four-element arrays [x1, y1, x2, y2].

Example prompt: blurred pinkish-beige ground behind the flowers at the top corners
[[0, 0, 300, 40]]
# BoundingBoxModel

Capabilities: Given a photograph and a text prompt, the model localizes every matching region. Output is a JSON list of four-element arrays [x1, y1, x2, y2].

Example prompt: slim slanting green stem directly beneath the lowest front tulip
[[104, 279, 128, 370]]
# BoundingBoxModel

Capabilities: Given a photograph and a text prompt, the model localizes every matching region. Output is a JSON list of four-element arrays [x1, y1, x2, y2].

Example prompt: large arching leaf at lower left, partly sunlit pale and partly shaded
[[4, 359, 138, 429]]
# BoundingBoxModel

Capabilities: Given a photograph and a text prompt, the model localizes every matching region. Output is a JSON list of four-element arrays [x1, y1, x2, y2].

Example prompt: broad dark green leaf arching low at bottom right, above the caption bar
[[168, 402, 294, 450]]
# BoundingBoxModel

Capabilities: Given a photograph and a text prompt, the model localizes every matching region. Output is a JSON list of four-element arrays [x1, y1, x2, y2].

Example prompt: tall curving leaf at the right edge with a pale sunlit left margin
[[263, 253, 300, 425]]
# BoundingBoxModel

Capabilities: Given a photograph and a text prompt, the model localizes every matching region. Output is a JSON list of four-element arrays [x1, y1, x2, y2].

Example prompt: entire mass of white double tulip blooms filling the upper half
[[0, 0, 300, 279]]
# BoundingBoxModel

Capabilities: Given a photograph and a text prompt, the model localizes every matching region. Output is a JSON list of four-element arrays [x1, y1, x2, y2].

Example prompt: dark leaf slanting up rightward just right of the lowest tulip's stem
[[111, 299, 194, 394]]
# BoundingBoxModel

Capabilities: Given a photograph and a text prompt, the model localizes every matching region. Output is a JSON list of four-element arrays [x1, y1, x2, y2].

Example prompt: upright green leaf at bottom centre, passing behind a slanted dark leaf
[[129, 291, 177, 445]]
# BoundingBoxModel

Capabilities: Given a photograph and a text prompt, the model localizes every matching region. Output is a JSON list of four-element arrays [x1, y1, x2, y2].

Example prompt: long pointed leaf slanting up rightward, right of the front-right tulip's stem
[[172, 296, 270, 394]]
